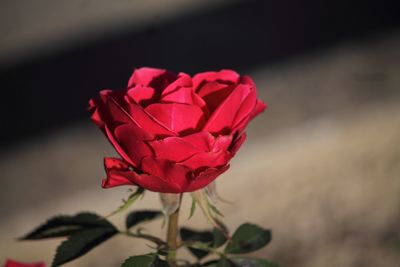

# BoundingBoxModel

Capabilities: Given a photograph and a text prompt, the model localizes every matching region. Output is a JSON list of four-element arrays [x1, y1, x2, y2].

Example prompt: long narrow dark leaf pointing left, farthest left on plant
[[20, 212, 113, 240]]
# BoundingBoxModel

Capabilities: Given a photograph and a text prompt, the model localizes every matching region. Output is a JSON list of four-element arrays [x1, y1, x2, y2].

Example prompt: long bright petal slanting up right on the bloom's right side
[[204, 84, 251, 133]]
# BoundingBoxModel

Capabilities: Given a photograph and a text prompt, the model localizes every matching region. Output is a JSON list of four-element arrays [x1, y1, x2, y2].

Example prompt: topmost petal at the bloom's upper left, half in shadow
[[128, 67, 176, 89]]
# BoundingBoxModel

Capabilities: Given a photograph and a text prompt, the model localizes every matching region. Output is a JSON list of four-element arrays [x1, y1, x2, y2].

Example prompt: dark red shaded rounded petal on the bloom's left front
[[114, 124, 152, 166]]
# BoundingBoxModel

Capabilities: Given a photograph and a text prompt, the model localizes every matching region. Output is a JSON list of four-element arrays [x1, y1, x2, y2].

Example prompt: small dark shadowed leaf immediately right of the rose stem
[[180, 227, 214, 260]]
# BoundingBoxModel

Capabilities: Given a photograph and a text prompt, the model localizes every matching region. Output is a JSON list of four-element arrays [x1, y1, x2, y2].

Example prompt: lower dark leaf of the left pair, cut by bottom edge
[[51, 226, 118, 267]]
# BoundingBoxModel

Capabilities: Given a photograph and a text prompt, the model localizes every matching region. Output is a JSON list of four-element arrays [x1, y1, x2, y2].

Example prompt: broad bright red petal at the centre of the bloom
[[145, 103, 204, 133]]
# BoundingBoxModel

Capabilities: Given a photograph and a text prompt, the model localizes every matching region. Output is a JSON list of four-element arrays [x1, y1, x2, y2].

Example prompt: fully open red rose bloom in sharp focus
[[89, 68, 265, 193]]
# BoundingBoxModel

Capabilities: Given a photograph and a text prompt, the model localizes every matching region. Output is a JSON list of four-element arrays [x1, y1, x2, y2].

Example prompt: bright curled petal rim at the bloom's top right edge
[[192, 70, 240, 92]]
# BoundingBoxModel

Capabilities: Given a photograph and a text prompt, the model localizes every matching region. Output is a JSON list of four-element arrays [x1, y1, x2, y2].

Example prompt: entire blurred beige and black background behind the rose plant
[[0, 0, 400, 267]]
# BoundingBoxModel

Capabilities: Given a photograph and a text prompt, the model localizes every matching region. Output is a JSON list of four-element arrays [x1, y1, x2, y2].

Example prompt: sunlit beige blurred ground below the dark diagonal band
[[0, 33, 400, 267]]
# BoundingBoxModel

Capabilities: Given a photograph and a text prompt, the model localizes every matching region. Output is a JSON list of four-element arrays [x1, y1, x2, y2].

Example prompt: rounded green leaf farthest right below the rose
[[225, 223, 271, 254]]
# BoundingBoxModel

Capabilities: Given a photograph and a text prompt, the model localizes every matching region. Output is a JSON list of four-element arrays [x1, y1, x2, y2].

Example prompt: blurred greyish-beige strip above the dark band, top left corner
[[0, 0, 228, 64]]
